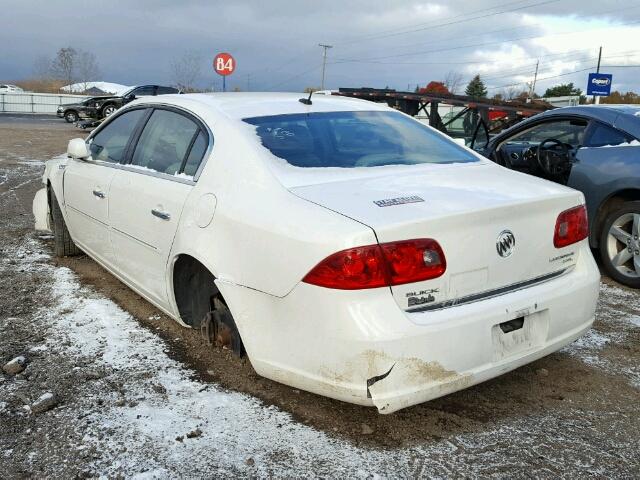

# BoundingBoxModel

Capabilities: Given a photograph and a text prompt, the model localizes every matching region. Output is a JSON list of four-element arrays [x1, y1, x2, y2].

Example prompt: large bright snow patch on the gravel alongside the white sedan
[[43, 268, 416, 477]]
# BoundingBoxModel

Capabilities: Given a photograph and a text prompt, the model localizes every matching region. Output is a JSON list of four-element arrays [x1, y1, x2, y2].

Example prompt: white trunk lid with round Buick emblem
[[290, 164, 583, 310]]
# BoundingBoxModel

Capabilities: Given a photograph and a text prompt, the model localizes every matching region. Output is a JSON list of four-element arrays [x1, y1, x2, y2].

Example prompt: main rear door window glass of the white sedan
[[131, 110, 200, 175]]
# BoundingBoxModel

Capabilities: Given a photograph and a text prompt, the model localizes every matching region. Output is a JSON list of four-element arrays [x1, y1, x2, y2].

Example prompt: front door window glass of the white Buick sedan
[[89, 109, 146, 163]]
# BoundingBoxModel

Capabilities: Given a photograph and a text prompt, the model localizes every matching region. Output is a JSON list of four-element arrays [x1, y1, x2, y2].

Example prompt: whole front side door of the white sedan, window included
[[63, 109, 145, 264]]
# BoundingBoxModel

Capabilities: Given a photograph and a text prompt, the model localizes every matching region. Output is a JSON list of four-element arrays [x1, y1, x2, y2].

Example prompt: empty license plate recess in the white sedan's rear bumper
[[491, 310, 549, 361]]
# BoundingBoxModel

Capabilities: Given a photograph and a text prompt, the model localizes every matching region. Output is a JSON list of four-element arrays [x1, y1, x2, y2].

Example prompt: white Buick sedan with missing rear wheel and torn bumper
[[34, 93, 599, 413]]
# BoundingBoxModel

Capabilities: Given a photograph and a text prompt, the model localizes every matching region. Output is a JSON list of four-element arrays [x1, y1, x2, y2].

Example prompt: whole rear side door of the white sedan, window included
[[109, 108, 209, 307]]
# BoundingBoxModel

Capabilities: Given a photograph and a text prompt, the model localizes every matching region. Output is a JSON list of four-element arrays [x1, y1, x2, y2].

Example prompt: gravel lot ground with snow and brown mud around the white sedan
[[0, 115, 640, 478]]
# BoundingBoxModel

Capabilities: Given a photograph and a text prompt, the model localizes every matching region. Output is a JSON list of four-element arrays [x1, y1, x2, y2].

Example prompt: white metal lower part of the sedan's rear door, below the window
[[109, 170, 193, 306]]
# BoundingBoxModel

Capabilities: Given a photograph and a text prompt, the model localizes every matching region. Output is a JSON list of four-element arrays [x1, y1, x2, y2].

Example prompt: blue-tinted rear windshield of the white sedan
[[244, 112, 478, 168]]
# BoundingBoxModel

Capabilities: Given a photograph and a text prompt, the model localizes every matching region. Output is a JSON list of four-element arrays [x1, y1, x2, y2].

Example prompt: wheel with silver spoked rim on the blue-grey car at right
[[599, 201, 640, 288]]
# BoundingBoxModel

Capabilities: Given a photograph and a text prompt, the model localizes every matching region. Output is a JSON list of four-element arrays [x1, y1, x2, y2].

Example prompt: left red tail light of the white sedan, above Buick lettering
[[302, 239, 447, 290]]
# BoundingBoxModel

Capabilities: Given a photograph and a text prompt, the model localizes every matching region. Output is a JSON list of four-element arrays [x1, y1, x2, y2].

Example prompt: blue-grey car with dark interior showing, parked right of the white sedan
[[484, 105, 640, 288]]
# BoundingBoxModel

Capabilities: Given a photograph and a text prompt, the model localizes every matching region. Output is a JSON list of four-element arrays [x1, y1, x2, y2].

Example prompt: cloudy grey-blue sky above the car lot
[[0, 0, 640, 94]]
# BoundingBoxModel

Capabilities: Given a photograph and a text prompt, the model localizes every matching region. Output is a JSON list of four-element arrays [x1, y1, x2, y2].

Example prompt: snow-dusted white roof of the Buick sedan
[[135, 92, 389, 120]]
